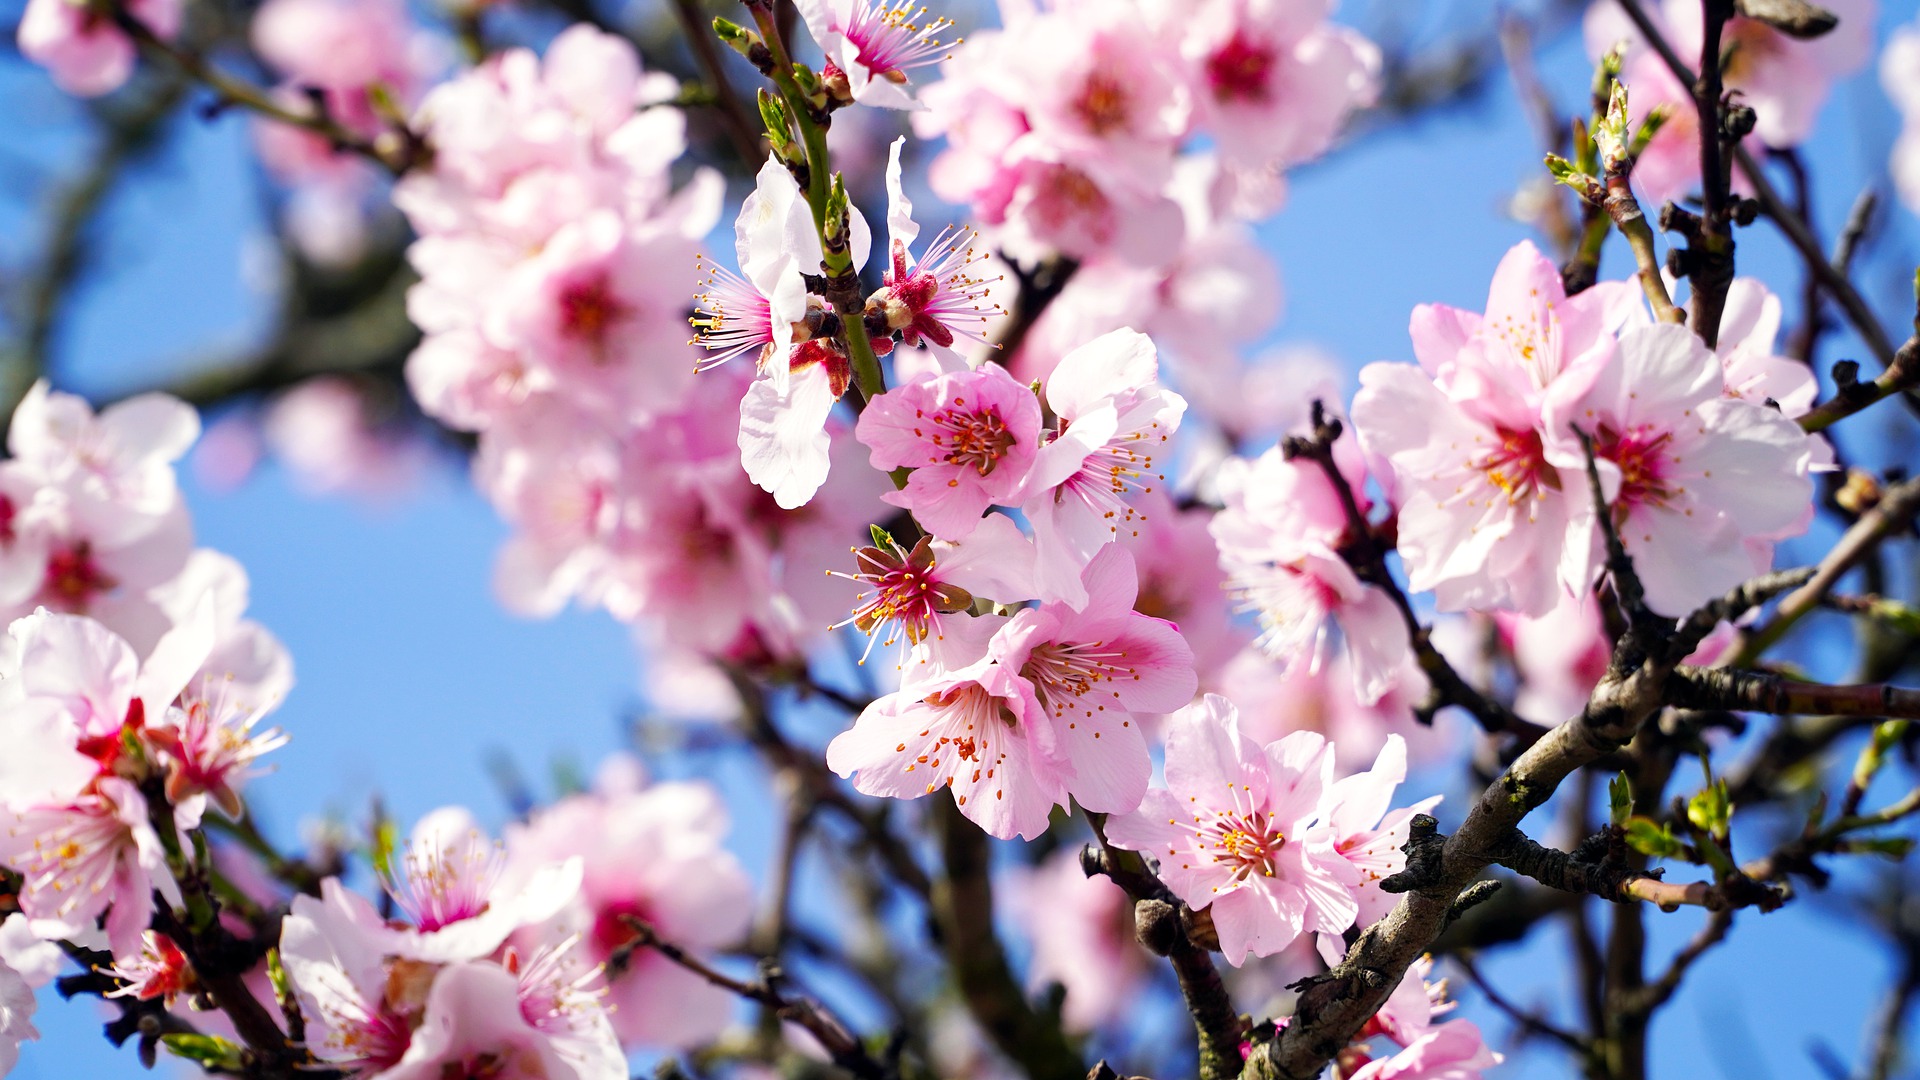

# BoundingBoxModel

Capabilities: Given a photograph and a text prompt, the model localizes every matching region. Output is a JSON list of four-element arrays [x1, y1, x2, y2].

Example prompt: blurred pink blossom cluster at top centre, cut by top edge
[[914, 0, 1380, 394]]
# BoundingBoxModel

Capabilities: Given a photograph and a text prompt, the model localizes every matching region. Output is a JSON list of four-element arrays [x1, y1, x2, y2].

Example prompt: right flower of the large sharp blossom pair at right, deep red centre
[[1563, 323, 1812, 617]]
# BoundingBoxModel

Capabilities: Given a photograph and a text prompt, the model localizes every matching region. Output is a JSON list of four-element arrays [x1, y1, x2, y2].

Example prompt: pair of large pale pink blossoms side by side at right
[[1354, 244, 1824, 615]]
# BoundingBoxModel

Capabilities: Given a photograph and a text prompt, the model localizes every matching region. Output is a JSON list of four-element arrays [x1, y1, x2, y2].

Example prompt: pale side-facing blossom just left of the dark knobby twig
[[1212, 440, 1411, 705]]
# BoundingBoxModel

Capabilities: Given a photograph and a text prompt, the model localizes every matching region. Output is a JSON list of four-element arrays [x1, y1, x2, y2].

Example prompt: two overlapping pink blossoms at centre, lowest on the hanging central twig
[[828, 546, 1196, 840]]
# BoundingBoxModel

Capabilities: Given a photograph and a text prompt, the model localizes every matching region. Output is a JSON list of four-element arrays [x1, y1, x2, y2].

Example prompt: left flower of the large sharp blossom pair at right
[[1354, 244, 1640, 615]]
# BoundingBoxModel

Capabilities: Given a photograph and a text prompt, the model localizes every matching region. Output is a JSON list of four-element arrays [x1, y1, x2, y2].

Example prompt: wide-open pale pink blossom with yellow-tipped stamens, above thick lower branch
[[1106, 694, 1359, 967]]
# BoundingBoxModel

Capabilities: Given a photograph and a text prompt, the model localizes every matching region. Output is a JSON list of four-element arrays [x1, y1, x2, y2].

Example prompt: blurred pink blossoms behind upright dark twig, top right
[[1586, 0, 1876, 206]]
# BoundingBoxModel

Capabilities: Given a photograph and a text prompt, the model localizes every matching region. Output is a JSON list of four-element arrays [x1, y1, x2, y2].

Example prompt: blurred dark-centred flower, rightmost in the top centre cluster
[[1156, 0, 1380, 175]]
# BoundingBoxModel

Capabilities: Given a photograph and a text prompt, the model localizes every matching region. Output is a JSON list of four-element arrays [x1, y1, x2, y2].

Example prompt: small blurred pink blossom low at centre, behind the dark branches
[[1004, 846, 1148, 1032]]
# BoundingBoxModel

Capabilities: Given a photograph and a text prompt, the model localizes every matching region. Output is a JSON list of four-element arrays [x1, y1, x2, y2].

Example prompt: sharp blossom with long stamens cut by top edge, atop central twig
[[799, 0, 952, 110]]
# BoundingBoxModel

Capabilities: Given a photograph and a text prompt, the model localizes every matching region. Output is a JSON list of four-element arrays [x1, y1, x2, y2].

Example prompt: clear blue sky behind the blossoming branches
[[0, 2, 1916, 1080]]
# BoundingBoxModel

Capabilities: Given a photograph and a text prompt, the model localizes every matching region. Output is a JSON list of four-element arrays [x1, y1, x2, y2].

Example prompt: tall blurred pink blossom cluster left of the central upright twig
[[396, 25, 885, 657]]
